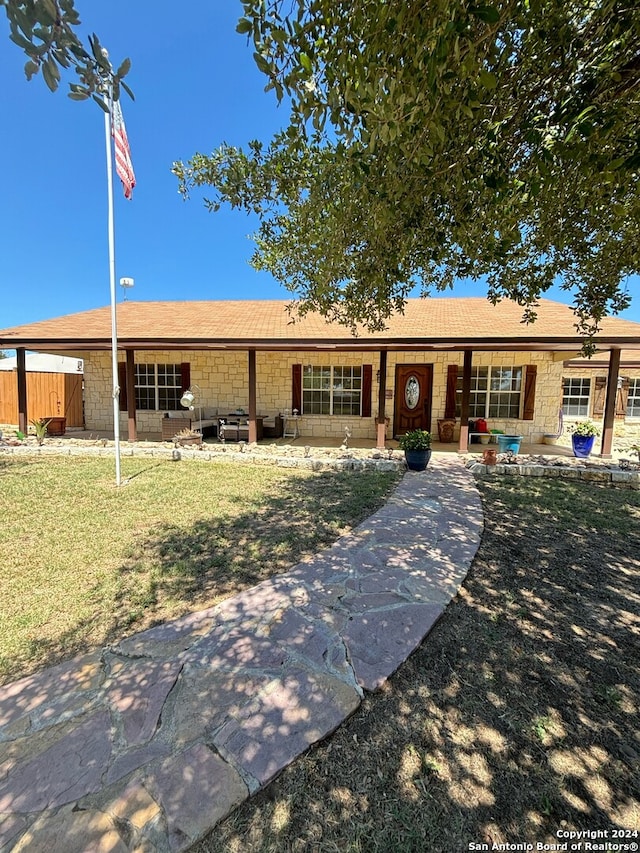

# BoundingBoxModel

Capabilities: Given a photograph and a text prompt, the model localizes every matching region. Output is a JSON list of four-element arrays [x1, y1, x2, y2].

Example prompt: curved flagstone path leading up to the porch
[[0, 457, 483, 853]]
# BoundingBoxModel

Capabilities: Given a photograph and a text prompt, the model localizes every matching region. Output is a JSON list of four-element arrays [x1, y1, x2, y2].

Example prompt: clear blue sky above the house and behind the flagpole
[[0, 0, 640, 328]]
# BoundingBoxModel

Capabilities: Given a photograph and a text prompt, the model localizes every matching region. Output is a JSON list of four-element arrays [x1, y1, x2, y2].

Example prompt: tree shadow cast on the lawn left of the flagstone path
[[0, 465, 398, 681]]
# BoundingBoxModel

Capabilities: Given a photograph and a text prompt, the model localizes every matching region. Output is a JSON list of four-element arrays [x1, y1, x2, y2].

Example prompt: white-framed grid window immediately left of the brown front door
[[302, 365, 362, 415]]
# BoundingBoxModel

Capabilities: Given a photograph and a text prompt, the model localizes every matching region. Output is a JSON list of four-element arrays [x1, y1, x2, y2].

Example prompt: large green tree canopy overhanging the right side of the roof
[[174, 0, 640, 335]]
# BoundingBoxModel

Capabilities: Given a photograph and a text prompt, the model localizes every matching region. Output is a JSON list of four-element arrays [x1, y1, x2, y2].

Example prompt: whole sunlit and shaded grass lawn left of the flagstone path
[[0, 457, 397, 683]]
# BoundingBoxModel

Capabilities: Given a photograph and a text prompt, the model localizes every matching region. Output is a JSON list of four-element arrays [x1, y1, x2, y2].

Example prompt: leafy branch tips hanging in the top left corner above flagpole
[[0, 0, 133, 107]]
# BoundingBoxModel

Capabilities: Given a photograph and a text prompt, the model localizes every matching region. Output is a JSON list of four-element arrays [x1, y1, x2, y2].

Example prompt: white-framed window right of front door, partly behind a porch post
[[456, 367, 523, 418]]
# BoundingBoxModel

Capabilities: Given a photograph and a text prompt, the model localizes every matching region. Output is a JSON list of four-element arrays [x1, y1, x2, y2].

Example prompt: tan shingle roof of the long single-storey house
[[0, 298, 640, 350]]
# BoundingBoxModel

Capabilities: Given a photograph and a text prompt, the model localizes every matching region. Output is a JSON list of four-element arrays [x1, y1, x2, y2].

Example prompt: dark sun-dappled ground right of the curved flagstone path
[[193, 479, 640, 853]]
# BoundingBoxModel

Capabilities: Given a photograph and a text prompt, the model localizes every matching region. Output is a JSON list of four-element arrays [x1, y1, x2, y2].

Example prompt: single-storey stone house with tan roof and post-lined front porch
[[0, 299, 640, 466]]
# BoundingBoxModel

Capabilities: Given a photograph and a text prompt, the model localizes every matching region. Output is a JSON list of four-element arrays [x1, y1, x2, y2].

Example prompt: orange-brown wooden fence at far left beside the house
[[0, 370, 84, 427]]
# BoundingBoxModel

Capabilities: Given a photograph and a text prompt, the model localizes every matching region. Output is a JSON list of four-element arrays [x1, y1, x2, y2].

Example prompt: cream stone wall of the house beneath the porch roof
[[82, 350, 563, 441]]
